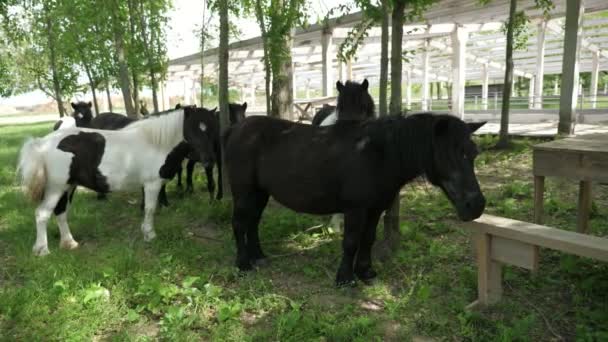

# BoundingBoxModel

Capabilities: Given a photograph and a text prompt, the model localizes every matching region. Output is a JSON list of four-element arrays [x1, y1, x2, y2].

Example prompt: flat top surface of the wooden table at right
[[532, 133, 608, 153]]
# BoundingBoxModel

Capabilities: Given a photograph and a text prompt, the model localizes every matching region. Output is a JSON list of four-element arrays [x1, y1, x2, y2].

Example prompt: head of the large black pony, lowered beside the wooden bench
[[426, 115, 486, 221]]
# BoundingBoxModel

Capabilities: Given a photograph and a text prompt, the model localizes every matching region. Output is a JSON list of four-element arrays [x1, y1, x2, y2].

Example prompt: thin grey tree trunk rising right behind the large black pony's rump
[[218, 0, 232, 198]]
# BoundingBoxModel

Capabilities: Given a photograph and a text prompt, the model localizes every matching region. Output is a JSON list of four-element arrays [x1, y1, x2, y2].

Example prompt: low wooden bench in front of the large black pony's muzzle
[[464, 215, 608, 308]]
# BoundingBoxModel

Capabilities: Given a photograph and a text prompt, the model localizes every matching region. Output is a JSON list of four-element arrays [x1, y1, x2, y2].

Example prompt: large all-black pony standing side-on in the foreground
[[225, 113, 485, 286]]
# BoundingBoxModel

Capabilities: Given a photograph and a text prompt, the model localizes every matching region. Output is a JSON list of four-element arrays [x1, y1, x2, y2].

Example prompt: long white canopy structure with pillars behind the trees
[[164, 0, 608, 119]]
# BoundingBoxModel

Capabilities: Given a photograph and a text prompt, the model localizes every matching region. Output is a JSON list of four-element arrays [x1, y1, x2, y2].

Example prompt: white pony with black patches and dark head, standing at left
[[17, 108, 210, 255]]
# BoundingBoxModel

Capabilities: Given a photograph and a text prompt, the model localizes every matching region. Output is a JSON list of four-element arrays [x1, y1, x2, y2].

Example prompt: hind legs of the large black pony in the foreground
[[232, 192, 268, 271]]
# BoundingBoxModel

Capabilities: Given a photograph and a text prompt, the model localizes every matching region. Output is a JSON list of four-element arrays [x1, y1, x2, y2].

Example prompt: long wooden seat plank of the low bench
[[464, 214, 608, 262]]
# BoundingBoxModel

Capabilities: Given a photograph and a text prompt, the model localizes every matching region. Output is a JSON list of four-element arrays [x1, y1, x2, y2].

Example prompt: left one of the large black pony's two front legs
[[336, 210, 367, 286]]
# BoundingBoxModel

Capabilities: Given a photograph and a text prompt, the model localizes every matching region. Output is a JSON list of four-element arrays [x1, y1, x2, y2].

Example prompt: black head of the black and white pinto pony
[[182, 106, 220, 167]]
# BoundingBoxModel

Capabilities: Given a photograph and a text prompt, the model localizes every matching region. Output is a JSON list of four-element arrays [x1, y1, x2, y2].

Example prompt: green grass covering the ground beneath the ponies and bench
[[0, 124, 608, 341]]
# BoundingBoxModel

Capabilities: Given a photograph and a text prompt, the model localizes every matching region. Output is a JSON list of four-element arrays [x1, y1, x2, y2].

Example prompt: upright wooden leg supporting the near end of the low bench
[[475, 233, 502, 305]]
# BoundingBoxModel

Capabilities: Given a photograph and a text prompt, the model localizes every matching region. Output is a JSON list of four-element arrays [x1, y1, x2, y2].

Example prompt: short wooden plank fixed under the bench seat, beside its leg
[[491, 236, 538, 272]]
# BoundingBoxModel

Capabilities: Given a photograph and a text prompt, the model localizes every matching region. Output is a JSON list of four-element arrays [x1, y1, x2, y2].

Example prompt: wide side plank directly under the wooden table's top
[[533, 149, 608, 182]]
